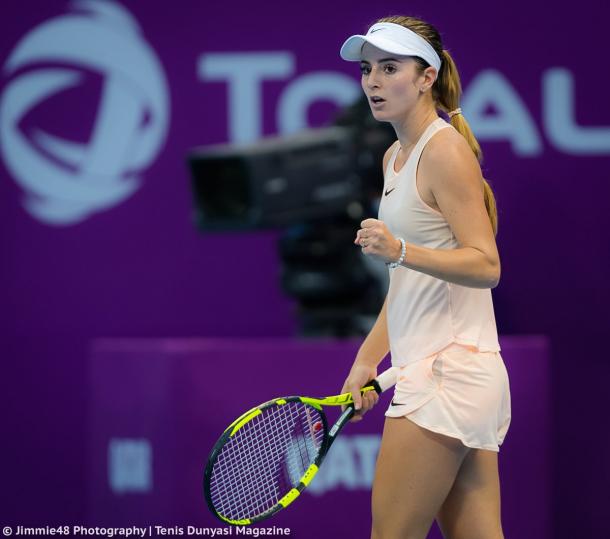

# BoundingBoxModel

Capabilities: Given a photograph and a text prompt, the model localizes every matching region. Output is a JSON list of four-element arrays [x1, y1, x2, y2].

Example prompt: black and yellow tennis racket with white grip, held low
[[203, 368, 397, 525]]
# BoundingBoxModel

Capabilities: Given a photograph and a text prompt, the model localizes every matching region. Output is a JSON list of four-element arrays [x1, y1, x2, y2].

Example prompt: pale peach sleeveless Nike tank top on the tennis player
[[379, 118, 500, 367]]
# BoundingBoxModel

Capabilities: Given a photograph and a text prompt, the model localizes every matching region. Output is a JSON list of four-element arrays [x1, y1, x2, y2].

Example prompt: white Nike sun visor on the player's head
[[339, 22, 441, 73]]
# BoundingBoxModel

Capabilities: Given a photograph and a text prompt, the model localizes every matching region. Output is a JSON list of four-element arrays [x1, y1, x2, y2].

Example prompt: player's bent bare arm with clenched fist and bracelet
[[355, 133, 500, 288]]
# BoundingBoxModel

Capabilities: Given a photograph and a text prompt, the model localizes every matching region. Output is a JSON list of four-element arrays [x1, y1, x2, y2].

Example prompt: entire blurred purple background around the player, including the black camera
[[0, 0, 610, 538]]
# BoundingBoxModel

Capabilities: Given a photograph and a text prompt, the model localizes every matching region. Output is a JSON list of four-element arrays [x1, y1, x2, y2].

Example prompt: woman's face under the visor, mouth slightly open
[[360, 43, 425, 122]]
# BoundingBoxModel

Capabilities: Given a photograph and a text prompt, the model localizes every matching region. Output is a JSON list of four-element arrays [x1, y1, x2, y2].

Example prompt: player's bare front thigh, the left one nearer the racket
[[372, 418, 468, 539]]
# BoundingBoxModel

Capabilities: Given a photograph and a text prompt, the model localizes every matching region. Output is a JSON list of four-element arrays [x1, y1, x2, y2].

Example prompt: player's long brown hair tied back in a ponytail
[[377, 16, 498, 234]]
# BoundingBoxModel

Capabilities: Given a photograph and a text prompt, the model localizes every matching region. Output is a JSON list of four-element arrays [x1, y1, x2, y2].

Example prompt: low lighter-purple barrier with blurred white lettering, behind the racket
[[87, 336, 553, 539]]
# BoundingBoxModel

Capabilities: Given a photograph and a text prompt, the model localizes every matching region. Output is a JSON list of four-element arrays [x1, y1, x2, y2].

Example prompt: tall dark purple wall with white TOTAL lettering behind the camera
[[0, 0, 610, 537]]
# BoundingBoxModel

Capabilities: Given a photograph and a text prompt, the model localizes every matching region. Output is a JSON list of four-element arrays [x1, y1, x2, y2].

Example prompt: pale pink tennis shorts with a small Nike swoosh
[[385, 343, 510, 451]]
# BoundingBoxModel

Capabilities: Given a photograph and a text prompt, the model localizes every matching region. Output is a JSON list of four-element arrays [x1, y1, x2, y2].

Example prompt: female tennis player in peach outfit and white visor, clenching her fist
[[341, 17, 510, 539]]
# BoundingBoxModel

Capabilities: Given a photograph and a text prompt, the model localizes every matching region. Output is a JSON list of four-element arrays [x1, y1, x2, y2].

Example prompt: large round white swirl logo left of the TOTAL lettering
[[0, 0, 169, 226]]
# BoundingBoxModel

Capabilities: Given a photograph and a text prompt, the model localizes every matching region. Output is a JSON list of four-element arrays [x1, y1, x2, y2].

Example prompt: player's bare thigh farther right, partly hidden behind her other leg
[[437, 449, 504, 539]]
